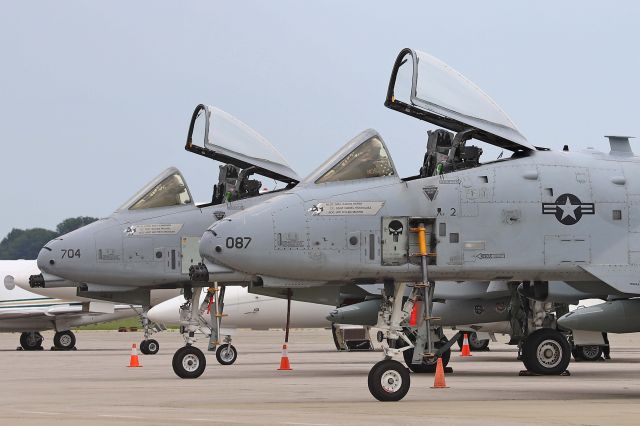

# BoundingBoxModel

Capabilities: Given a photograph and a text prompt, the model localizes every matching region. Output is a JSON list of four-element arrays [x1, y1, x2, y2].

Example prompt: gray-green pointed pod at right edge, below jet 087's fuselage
[[558, 299, 640, 333]]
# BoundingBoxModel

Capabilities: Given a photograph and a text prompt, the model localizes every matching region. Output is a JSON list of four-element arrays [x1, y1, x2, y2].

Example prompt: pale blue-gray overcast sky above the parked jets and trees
[[0, 0, 640, 238]]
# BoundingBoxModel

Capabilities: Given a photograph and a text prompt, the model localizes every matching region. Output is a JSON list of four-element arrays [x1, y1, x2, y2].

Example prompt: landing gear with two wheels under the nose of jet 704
[[172, 285, 238, 379]]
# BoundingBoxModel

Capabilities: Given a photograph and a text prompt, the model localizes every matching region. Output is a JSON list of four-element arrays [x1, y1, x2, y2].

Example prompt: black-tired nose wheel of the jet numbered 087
[[368, 359, 411, 401]]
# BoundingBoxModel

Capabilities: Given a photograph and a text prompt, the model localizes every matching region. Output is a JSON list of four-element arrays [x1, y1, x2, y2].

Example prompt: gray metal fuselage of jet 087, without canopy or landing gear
[[200, 130, 640, 294]]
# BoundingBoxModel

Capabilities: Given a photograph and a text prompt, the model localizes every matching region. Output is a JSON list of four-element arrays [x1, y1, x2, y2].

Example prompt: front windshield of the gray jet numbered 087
[[316, 136, 394, 183]]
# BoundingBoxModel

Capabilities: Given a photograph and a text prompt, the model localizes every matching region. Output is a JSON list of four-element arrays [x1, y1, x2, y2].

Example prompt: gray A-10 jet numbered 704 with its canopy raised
[[29, 105, 300, 362]]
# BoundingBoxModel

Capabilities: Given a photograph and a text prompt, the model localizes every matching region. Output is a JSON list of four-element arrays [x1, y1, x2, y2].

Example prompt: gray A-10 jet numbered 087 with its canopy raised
[[192, 49, 640, 400]]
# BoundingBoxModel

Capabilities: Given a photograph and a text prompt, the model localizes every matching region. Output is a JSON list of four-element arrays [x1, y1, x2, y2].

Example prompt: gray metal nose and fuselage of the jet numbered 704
[[33, 168, 277, 294]]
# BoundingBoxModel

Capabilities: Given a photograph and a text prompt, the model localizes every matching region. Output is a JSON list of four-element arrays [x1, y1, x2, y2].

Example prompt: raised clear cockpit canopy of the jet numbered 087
[[385, 48, 536, 151]]
